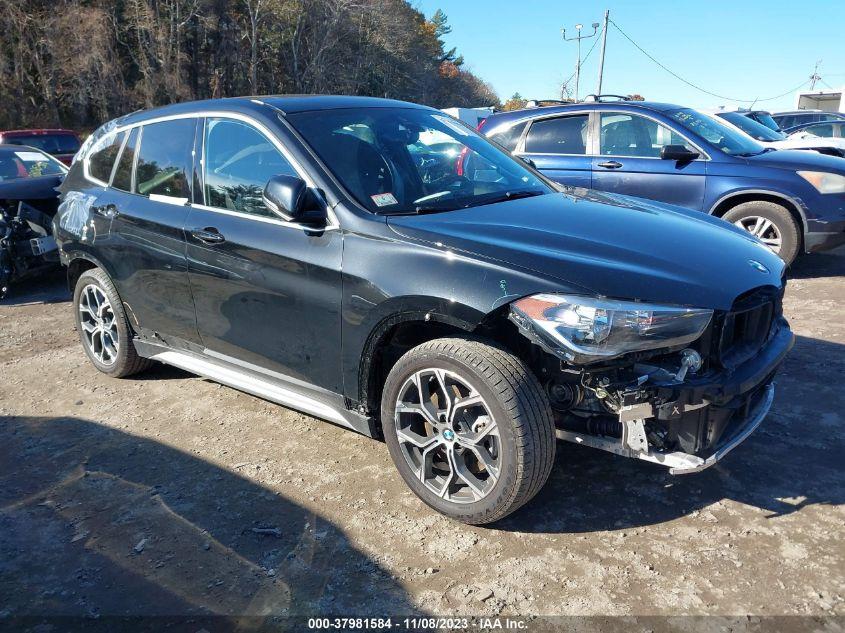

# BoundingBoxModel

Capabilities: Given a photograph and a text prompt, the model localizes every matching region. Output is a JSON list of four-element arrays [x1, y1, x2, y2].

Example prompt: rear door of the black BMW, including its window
[[98, 119, 199, 342]]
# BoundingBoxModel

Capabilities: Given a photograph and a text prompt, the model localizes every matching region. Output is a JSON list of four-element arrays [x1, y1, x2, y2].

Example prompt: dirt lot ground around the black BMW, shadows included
[[0, 249, 845, 617]]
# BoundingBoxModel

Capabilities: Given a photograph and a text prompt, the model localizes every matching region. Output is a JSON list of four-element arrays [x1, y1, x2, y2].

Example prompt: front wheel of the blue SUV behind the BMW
[[722, 200, 801, 266]]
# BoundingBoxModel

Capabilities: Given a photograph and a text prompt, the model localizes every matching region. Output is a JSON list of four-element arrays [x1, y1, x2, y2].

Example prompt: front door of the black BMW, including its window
[[185, 113, 343, 393]]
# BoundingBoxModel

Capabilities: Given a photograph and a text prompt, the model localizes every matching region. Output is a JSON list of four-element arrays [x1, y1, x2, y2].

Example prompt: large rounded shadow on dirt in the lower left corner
[[0, 417, 422, 630]]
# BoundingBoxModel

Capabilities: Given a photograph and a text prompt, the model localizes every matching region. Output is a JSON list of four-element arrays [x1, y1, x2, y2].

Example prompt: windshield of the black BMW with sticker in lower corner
[[287, 108, 553, 214]]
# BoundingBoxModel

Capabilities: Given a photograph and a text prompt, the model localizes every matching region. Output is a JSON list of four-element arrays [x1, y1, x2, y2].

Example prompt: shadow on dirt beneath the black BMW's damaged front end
[[496, 336, 845, 533]]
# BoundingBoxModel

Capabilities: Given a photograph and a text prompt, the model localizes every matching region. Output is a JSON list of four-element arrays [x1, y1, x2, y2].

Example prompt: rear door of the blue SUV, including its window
[[519, 114, 592, 188]]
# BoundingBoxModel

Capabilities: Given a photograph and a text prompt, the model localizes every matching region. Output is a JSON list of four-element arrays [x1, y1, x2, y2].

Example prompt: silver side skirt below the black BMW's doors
[[133, 339, 375, 437]]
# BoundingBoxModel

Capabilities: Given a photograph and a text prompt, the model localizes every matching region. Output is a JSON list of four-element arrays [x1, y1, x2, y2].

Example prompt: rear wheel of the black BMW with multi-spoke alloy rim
[[73, 268, 153, 378]]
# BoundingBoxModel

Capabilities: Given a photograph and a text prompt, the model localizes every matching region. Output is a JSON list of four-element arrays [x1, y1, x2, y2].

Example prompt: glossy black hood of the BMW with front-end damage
[[387, 190, 784, 310]]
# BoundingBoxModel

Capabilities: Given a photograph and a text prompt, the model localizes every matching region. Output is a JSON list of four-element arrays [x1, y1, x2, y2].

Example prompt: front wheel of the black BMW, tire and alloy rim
[[381, 338, 555, 525]]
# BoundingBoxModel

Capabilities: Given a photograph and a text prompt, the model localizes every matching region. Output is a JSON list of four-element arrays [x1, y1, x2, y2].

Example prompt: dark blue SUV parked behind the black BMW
[[478, 100, 845, 263]]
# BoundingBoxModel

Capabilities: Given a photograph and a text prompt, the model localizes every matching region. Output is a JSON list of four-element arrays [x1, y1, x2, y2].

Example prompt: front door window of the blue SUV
[[599, 113, 695, 158]]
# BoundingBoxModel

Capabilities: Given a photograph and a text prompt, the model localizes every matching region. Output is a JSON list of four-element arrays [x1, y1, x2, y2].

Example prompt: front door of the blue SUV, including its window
[[592, 112, 707, 210]]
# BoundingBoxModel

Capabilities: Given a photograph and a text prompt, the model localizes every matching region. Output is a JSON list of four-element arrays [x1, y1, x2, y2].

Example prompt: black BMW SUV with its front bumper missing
[[54, 96, 793, 524]]
